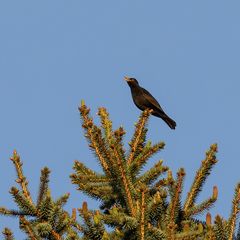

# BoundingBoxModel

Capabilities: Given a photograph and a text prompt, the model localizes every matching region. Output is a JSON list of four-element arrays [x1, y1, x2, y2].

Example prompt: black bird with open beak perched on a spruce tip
[[124, 77, 177, 129]]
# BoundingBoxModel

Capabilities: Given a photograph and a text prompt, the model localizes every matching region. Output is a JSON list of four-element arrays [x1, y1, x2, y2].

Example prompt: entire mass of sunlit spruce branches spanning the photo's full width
[[0, 102, 240, 240]]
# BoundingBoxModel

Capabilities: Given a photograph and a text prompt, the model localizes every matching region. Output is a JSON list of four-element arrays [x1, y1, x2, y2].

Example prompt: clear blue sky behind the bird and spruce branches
[[0, 0, 240, 239]]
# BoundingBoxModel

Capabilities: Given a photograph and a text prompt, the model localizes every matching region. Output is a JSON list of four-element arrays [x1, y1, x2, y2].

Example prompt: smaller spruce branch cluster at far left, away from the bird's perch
[[0, 151, 81, 240]]
